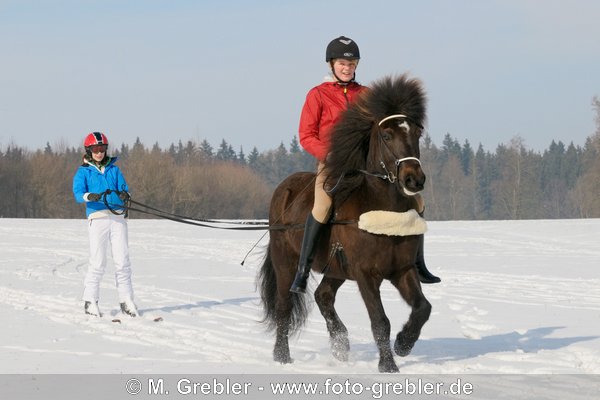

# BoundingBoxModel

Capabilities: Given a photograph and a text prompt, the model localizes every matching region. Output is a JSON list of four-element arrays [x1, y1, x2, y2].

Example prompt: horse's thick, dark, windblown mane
[[325, 74, 427, 204]]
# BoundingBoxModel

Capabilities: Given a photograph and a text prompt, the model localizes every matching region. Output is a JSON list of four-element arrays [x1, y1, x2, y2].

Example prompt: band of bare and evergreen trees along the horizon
[[0, 98, 600, 220]]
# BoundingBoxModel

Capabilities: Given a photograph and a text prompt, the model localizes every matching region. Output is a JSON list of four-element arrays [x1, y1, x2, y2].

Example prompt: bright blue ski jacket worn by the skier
[[73, 157, 129, 217]]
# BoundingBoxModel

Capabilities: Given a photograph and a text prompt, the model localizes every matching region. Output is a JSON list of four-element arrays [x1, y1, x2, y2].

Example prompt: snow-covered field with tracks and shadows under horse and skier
[[0, 219, 600, 398]]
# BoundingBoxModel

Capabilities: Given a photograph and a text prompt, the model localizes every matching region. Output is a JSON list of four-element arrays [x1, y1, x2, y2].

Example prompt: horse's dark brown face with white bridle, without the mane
[[376, 114, 425, 196]]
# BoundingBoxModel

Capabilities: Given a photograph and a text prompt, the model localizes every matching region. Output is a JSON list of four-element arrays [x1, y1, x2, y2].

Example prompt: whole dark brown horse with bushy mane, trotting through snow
[[258, 75, 431, 372]]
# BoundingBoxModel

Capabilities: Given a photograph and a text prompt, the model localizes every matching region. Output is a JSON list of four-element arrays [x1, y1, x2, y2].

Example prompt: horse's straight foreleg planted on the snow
[[357, 276, 398, 372]]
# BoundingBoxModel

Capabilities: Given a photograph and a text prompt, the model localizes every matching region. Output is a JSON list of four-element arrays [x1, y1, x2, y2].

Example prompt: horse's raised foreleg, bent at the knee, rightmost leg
[[391, 268, 431, 357]]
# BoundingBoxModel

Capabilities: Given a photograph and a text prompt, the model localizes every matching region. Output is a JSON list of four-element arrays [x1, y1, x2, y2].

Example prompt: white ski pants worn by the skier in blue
[[83, 215, 133, 302]]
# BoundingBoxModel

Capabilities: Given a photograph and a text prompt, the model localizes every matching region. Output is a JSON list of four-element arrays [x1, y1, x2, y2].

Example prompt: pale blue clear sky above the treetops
[[0, 0, 600, 153]]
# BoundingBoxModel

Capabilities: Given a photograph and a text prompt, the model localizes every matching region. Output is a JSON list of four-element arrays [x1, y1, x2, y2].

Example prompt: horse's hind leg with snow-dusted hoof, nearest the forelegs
[[315, 276, 350, 361]]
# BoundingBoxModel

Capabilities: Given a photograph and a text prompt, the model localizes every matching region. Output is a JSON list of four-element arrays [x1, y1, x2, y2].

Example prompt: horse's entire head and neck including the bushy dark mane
[[325, 75, 426, 202]]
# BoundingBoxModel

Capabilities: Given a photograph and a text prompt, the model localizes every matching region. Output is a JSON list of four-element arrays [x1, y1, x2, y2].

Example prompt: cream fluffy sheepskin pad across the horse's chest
[[358, 210, 427, 236]]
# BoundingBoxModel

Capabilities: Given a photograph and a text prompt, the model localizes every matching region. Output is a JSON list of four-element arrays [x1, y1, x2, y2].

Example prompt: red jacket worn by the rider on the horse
[[298, 82, 366, 161]]
